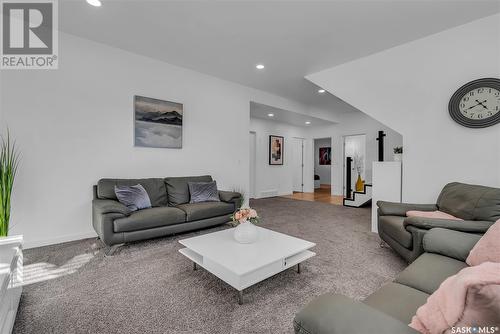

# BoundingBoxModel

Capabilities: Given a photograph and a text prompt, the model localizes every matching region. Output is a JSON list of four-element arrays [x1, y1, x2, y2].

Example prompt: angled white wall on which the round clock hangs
[[307, 14, 500, 202]]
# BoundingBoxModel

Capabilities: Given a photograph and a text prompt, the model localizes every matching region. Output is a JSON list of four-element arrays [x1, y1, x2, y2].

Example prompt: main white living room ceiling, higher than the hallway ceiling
[[59, 0, 500, 114]]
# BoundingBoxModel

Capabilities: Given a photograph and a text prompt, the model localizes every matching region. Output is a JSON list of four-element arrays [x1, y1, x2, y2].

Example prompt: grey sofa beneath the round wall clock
[[377, 182, 500, 262]]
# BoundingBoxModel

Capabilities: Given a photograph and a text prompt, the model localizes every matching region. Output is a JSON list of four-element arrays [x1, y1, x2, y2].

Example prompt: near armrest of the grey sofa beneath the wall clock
[[403, 217, 494, 233]]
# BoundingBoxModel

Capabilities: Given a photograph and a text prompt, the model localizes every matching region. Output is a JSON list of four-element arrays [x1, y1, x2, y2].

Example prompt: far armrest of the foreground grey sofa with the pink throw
[[424, 228, 482, 262]]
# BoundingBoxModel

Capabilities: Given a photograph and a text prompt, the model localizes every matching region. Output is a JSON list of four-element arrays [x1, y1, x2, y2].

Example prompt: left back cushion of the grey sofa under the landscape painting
[[97, 178, 168, 207]]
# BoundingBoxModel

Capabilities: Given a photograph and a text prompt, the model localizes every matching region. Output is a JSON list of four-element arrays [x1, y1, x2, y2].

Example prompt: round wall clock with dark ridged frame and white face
[[448, 78, 500, 128]]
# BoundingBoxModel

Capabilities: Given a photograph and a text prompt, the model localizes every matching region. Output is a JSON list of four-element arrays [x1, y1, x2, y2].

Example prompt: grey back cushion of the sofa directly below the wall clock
[[437, 182, 500, 221]]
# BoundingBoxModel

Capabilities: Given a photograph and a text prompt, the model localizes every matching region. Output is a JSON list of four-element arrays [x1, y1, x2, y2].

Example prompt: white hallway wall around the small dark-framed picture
[[250, 118, 314, 198]]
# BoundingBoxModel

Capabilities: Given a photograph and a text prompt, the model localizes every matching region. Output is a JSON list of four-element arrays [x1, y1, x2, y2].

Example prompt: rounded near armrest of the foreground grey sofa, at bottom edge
[[293, 294, 418, 334]]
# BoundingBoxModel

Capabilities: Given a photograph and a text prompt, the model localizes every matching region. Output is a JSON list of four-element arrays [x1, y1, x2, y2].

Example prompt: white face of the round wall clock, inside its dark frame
[[459, 87, 500, 120]]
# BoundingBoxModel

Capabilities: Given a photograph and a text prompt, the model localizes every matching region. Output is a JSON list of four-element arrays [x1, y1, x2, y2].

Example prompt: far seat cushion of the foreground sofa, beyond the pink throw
[[394, 253, 467, 294]]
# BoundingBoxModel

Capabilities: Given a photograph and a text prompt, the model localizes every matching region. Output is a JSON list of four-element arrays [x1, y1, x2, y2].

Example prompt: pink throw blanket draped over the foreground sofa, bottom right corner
[[410, 262, 500, 334]]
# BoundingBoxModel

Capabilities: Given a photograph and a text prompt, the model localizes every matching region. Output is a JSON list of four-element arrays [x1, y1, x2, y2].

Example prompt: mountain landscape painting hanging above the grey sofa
[[134, 96, 183, 148]]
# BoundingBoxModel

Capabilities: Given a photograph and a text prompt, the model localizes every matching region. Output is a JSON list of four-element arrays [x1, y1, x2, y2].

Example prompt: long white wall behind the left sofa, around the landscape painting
[[0, 33, 328, 247]]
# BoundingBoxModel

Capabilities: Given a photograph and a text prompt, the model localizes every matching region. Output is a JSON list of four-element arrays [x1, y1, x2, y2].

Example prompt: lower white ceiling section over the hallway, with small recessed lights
[[250, 102, 336, 127]]
